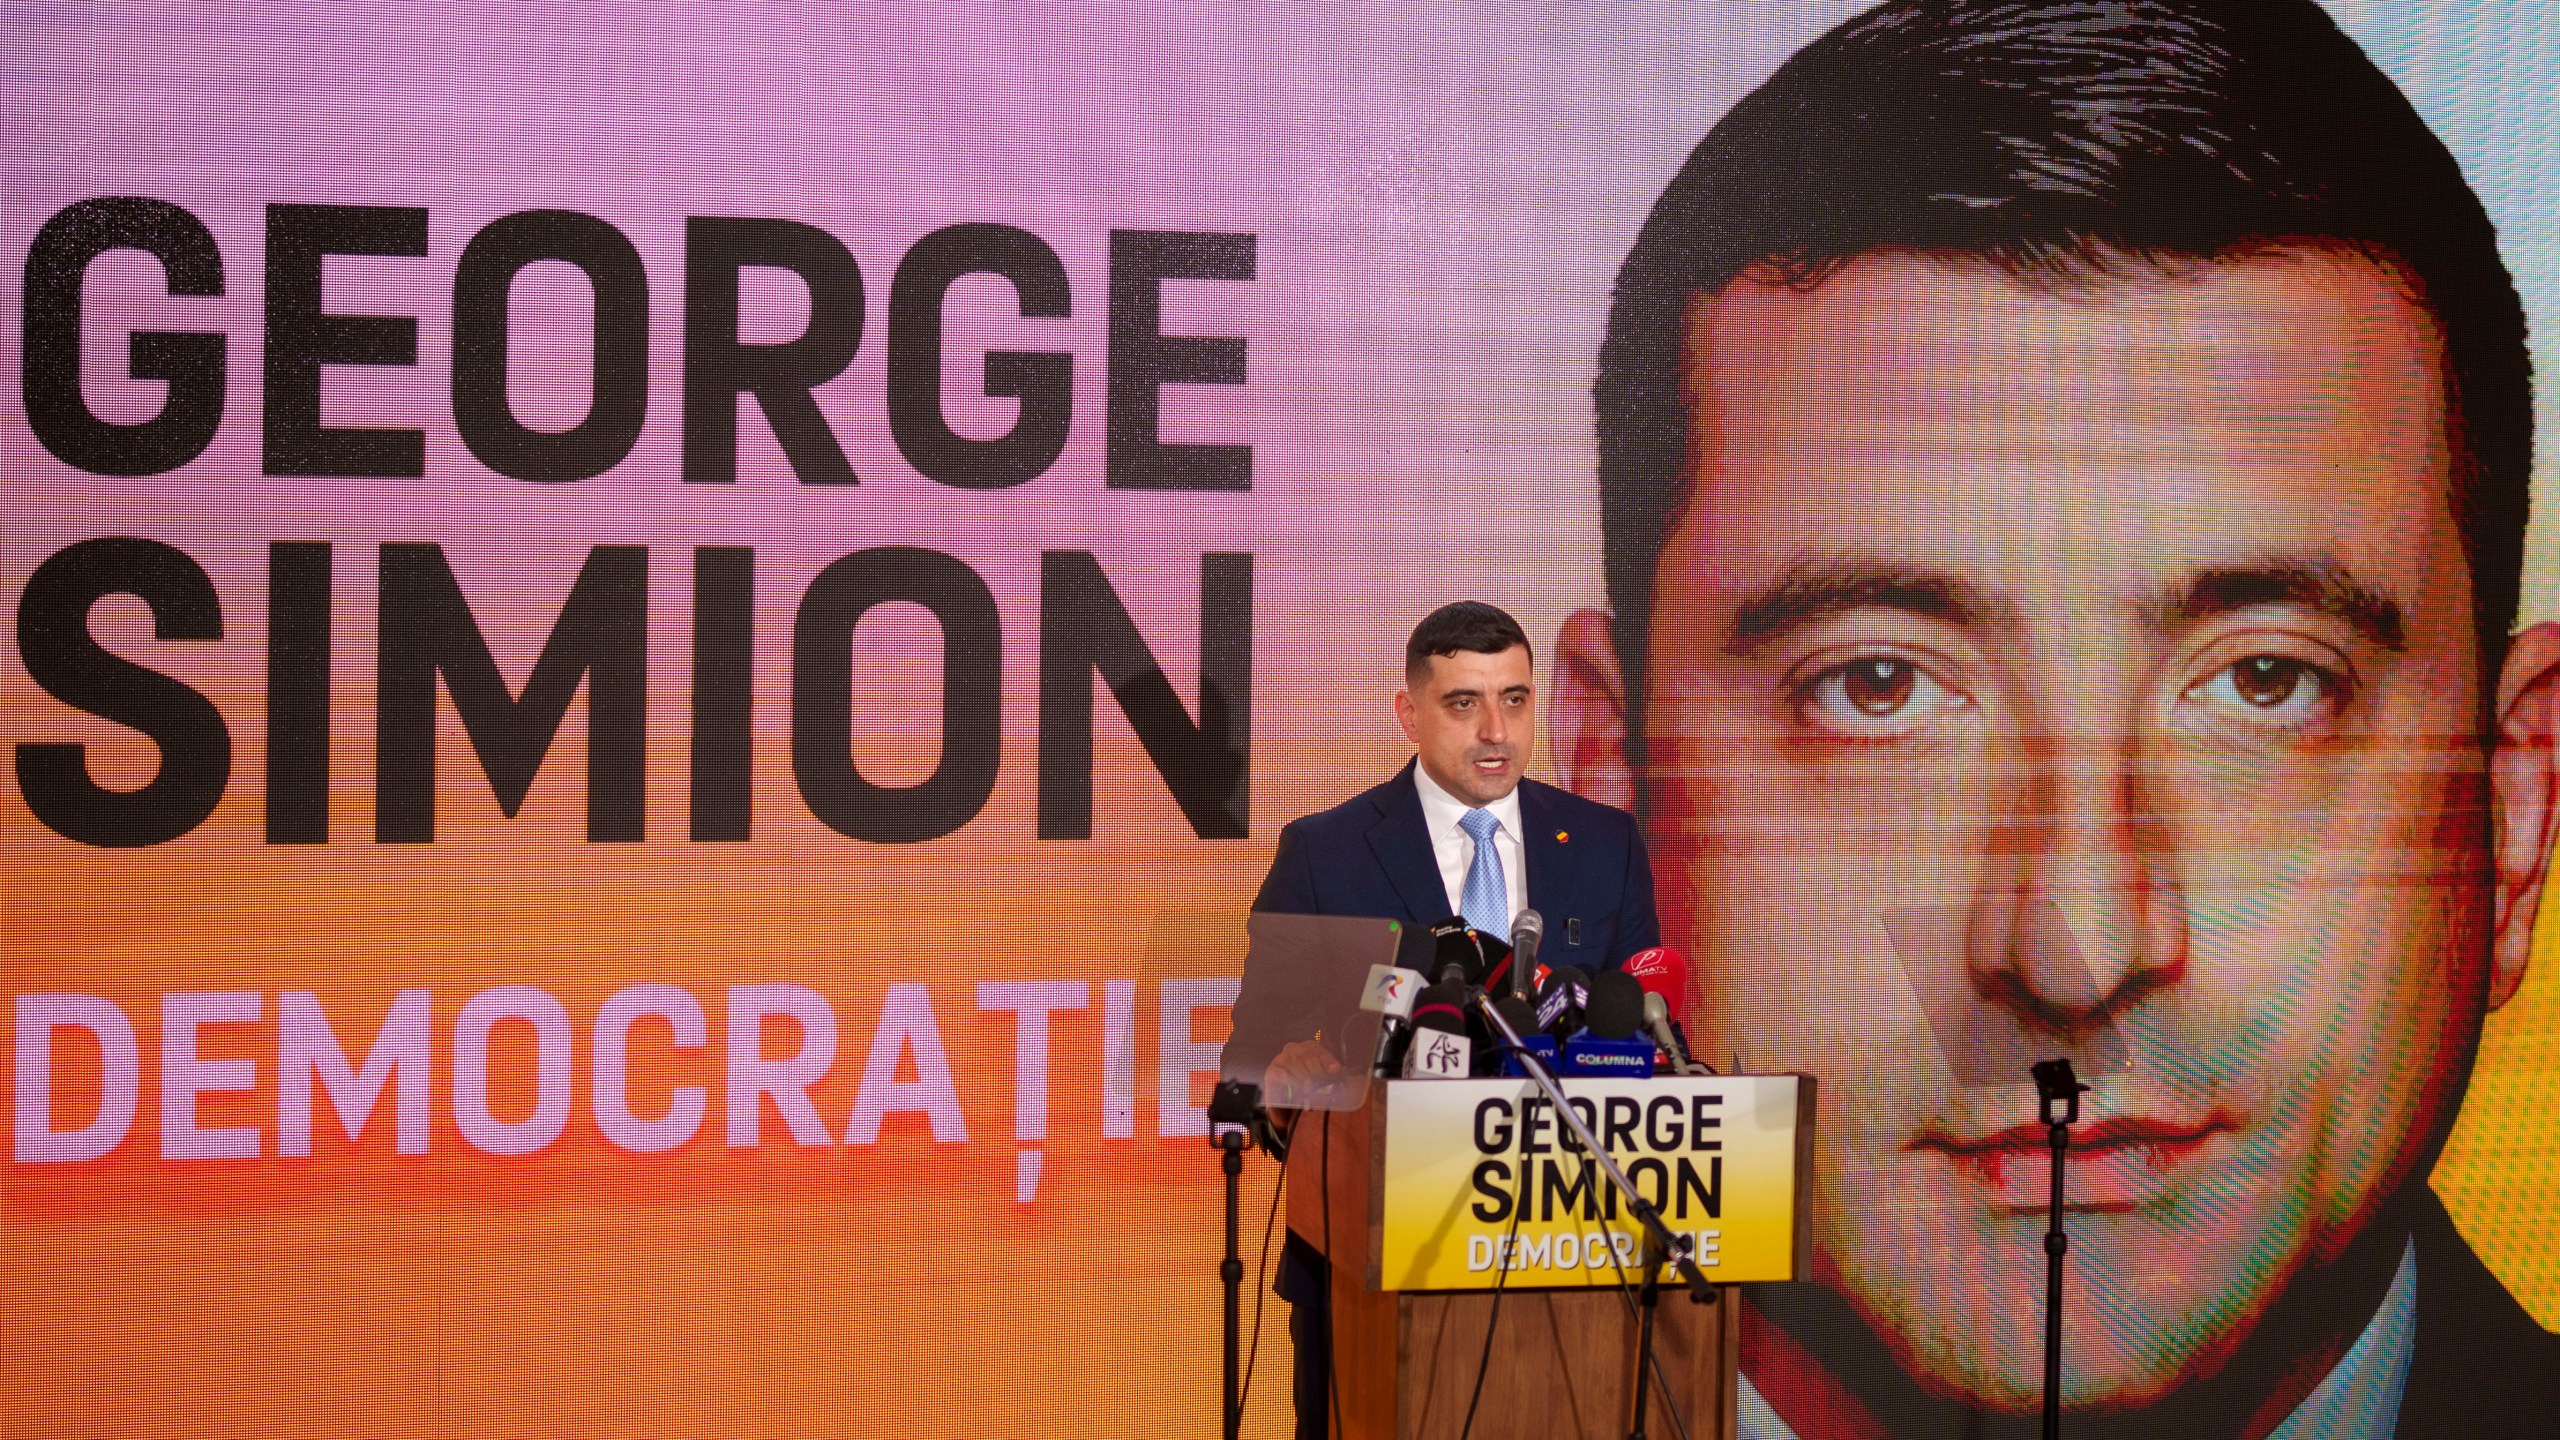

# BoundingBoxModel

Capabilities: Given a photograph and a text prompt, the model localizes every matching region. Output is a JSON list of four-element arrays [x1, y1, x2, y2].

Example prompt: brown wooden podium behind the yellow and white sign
[[1288, 1076, 1812, 1440]]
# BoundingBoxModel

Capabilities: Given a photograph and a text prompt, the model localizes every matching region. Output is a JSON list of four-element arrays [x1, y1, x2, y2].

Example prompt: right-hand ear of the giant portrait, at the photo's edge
[[2488, 620, 2560, 1010]]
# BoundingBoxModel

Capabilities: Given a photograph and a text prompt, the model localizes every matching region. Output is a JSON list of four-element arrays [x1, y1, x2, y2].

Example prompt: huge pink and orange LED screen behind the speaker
[[0, 0, 2560, 1440]]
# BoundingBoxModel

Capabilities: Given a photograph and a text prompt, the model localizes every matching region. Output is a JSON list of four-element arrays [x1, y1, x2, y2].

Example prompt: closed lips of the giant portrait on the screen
[[1907, 1109, 2237, 1212]]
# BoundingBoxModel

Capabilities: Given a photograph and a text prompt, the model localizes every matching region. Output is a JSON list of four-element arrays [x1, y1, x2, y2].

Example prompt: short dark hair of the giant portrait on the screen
[[1592, 0, 2532, 776]]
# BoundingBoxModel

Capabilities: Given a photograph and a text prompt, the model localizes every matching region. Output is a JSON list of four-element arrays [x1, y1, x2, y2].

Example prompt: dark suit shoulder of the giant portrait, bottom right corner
[[2396, 1191, 2560, 1440]]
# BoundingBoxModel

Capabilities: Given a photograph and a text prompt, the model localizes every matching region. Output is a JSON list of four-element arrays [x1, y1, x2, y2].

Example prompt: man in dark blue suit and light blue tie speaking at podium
[[1236, 600, 1661, 1440]]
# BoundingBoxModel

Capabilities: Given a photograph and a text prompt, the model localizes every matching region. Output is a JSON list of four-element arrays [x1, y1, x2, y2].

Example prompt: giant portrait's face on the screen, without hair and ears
[[1607, 254, 2493, 1409]]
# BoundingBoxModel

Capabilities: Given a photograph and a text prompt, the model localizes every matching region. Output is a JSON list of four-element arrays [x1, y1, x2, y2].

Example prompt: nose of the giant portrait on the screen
[[1966, 725, 2186, 1033]]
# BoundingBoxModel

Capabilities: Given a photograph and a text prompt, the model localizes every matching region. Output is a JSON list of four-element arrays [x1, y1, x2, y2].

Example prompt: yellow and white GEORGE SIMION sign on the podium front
[[1375, 1076, 1815, 1291]]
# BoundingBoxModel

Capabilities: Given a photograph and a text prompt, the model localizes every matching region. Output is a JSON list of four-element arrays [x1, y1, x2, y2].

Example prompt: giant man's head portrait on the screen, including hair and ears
[[1556, 3, 2560, 1435]]
